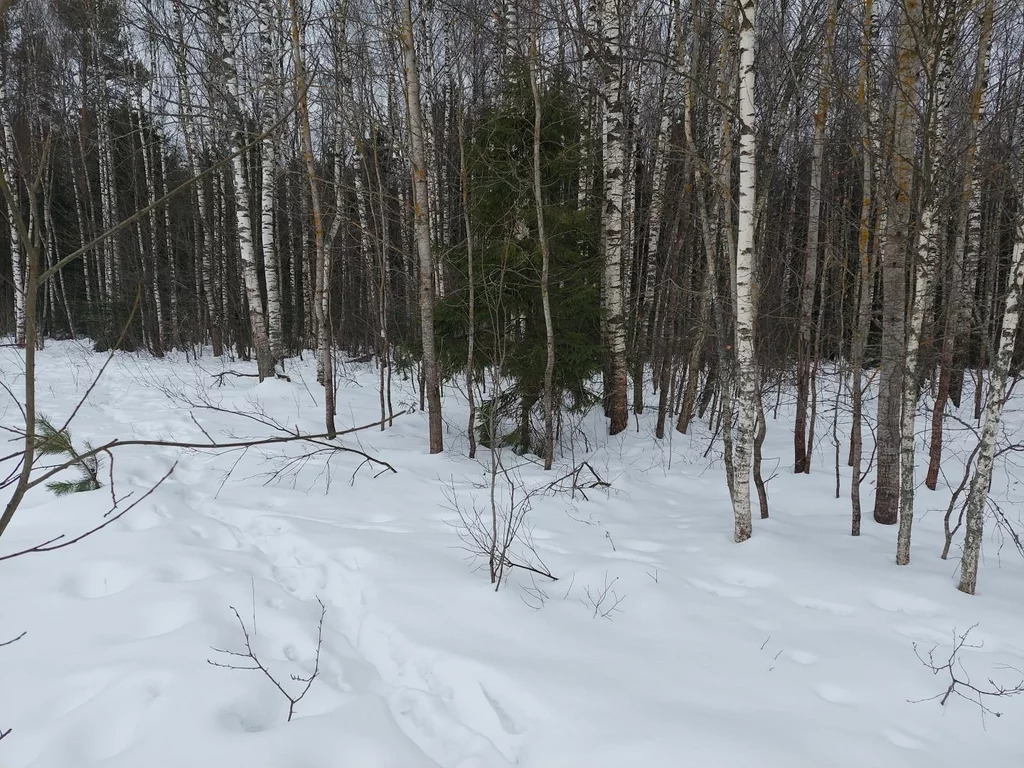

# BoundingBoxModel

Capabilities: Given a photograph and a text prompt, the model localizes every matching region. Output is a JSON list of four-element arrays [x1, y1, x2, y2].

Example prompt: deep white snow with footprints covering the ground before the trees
[[0, 342, 1024, 768]]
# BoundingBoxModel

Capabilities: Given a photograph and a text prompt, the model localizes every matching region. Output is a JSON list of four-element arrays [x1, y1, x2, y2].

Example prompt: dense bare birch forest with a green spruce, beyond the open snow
[[0, 0, 1024, 765]]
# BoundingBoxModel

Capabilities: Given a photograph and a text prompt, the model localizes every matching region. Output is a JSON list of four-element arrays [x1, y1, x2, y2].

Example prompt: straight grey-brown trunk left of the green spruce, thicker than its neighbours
[[401, 0, 444, 454]]
